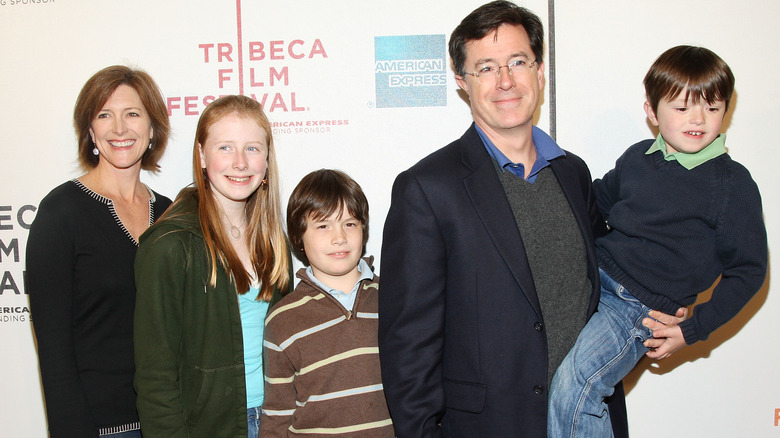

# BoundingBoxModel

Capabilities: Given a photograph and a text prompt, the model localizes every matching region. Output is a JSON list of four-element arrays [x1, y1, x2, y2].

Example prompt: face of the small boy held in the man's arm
[[645, 90, 726, 154]]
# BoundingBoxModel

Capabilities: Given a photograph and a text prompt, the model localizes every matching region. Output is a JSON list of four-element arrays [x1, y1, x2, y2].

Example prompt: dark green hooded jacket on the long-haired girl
[[134, 192, 293, 438]]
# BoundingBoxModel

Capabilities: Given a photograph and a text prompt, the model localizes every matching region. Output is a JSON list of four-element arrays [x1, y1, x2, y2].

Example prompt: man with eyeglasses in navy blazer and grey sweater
[[379, 1, 676, 438]]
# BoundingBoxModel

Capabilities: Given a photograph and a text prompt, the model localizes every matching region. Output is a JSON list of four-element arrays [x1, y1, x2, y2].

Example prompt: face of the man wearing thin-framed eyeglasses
[[455, 24, 544, 136]]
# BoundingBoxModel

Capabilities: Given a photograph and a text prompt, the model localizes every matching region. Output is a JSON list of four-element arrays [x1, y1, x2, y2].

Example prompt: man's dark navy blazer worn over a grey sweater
[[379, 125, 627, 438]]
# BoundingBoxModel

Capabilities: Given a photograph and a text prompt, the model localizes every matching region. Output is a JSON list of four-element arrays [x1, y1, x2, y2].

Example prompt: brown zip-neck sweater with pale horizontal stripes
[[260, 269, 395, 437]]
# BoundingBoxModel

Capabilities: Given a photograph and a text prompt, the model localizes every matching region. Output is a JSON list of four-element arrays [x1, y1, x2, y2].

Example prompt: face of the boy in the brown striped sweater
[[303, 207, 363, 293]]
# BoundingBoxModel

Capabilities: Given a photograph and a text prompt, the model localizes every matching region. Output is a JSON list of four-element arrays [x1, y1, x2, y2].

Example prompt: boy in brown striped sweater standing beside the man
[[260, 169, 394, 437]]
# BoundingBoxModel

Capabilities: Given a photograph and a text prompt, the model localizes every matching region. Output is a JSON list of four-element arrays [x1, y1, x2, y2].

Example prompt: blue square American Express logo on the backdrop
[[374, 35, 447, 108]]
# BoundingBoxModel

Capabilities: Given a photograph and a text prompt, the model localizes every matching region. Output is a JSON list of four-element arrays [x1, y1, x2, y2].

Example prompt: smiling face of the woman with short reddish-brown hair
[[89, 85, 153, 171]]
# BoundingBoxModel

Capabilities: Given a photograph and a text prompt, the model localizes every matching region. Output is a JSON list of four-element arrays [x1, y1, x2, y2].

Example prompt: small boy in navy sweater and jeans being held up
[[548, 46, 767, 438]]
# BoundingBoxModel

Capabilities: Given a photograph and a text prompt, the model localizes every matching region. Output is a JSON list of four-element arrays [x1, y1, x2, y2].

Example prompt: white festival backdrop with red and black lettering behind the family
[[0, 0, 780, 437]]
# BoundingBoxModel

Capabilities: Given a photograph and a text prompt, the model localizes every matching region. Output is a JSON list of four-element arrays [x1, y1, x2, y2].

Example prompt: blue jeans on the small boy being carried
[[547, 270, 652, 438]]
